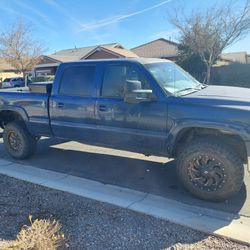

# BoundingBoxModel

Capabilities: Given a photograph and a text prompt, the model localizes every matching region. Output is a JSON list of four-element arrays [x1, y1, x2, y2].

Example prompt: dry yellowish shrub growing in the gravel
[[0, 216, 64, 250]]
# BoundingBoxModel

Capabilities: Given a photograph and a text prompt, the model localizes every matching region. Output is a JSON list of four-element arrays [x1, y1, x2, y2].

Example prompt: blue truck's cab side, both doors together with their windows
[[50, 60, 167, 155]]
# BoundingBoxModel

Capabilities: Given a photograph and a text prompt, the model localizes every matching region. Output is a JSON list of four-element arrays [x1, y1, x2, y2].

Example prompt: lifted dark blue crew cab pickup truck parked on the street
[[0, 58, 250, 201]]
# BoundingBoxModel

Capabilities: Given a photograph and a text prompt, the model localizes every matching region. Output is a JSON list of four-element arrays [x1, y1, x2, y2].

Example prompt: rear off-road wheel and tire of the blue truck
[[3, 122, 37, 159]]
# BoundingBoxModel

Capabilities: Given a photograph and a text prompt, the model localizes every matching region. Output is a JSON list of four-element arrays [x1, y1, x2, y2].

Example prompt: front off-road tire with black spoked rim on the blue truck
[[177, 137, 244, 201]]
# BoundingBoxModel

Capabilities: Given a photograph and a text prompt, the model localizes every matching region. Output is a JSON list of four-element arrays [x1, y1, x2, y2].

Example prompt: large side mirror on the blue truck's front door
[[124, 80, 156, 103]]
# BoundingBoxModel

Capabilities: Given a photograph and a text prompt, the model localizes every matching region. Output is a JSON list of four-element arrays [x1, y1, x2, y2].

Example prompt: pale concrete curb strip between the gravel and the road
[[0, 160, 250, 245]]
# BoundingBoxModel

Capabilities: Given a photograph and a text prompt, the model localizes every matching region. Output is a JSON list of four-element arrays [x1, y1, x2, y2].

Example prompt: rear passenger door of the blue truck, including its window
[[50, 64, 96, 142]]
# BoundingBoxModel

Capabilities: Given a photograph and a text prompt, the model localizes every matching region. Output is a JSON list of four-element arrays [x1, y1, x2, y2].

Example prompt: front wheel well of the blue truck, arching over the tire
[[173, 128, 247, 163]]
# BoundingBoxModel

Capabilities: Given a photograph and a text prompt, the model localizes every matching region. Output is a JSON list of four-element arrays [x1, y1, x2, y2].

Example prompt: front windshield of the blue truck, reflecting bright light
[[145, 62, 204, 95]]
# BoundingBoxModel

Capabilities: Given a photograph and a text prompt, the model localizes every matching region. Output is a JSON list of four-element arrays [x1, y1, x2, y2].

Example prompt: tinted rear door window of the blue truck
[[59, 66, 95, 96]]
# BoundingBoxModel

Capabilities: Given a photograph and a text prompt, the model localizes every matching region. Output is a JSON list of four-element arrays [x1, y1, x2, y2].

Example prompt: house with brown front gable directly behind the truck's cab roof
[[35, 43, 138, 76]]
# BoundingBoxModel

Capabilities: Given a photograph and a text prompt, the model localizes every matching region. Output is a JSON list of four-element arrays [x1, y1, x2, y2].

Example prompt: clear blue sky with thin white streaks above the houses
[[0, 0, 250, 53]]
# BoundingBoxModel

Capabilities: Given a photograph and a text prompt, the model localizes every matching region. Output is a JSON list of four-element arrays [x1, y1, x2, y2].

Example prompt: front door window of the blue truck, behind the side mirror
[[101, 65, 150, 98]]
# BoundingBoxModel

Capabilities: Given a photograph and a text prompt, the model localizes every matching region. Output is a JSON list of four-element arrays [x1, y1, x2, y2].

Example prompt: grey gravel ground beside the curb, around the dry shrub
[[0, 175, 250, 250]]
